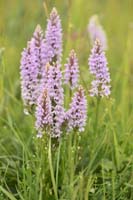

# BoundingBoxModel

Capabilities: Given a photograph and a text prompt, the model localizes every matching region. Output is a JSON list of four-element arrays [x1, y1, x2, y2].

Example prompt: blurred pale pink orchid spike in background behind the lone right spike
[[88, 15, 108, 50]]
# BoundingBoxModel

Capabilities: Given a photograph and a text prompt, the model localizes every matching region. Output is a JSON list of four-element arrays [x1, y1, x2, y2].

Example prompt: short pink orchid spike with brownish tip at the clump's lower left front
[[35, 89, 53, 137]]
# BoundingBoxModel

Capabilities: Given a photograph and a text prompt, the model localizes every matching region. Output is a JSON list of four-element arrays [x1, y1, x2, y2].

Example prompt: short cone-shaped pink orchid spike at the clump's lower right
[[66, 87, 87, 132]]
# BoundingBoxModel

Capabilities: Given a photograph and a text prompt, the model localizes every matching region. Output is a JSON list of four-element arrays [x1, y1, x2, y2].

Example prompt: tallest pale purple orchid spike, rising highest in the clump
[[42, 8, 62, 65]]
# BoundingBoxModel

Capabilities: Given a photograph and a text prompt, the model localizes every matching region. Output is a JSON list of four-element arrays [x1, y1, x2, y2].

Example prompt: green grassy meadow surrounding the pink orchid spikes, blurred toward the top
[[0, 0, 133, 200]]
